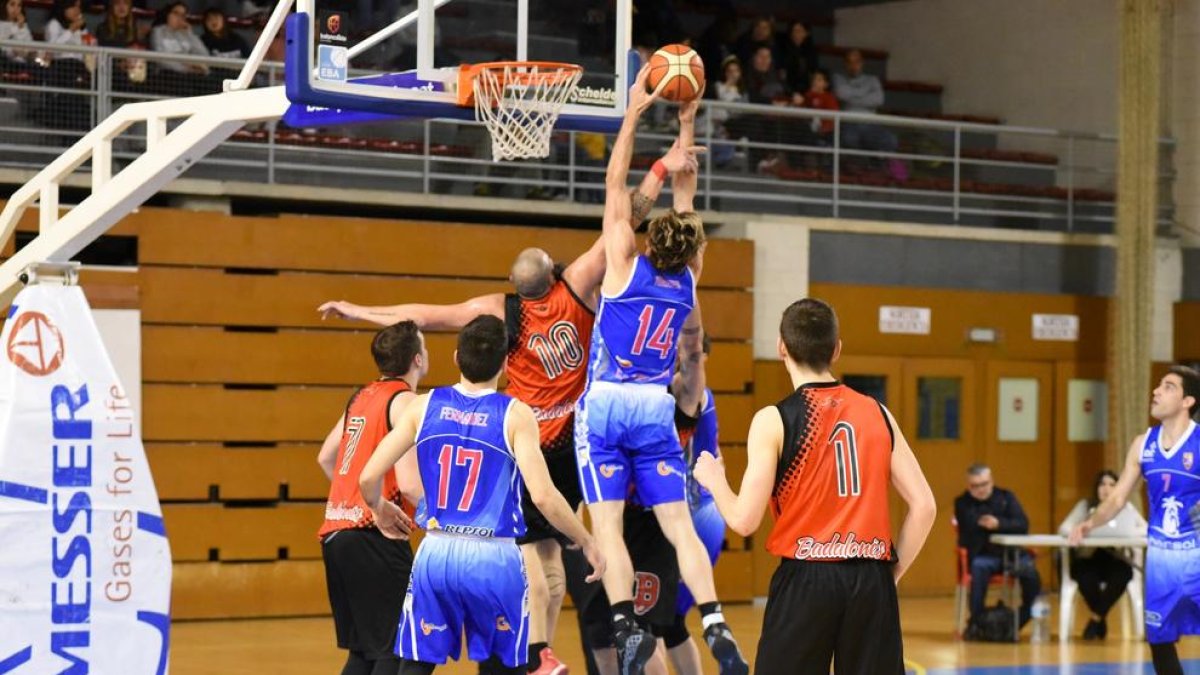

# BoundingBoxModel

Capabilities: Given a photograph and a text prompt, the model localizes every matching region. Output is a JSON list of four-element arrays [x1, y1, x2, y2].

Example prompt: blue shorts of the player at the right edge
[[1146, 543, 1200, 645]]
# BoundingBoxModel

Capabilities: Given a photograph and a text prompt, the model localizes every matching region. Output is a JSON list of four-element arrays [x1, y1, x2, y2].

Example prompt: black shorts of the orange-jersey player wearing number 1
[[755, 560, 905, 675]]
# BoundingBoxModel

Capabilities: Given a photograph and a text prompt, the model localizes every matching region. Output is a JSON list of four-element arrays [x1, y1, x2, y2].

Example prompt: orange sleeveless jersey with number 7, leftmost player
[[317, 380, 414, 537]]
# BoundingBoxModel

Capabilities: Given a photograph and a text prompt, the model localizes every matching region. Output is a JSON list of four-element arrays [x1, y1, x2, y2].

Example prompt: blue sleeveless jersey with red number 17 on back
[[416, 386, 526, 537]]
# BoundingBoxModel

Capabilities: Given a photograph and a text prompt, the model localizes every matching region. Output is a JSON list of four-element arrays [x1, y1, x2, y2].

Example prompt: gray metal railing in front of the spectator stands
[[0, 41, 1174, 233]]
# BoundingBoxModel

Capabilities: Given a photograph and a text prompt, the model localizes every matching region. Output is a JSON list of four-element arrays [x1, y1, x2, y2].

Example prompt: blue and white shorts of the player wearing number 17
[[396, 532, 529, 668]]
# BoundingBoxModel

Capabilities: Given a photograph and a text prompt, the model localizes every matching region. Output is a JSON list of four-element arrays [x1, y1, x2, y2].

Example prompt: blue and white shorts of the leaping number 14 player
[[575, 382, 686, 507]]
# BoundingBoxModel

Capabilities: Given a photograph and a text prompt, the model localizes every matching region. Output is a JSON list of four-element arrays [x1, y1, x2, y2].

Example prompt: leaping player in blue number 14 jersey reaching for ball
[[575, 68, 749, 675]]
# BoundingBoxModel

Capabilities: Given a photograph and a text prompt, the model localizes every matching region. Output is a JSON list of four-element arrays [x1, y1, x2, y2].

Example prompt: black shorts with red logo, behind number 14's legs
[[568, 504, 679, 649]]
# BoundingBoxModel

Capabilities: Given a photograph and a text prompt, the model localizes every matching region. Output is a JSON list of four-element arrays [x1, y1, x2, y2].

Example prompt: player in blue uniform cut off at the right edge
[[1070, 365, 1200, 675]]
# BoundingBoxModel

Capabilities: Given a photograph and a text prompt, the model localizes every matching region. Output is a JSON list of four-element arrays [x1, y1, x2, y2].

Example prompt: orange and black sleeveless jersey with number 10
[[504, 273, 595, 453]]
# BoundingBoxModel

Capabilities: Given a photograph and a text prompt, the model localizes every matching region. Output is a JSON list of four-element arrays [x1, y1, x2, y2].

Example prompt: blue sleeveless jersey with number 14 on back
[[588, 256, 696, 386]]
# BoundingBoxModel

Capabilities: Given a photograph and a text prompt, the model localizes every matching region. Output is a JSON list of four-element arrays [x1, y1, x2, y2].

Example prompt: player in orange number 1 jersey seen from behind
[[695, 299, 937, 675]]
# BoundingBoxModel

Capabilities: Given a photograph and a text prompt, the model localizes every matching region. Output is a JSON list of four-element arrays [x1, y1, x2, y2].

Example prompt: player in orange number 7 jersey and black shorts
[[317, 321, 430, 675]]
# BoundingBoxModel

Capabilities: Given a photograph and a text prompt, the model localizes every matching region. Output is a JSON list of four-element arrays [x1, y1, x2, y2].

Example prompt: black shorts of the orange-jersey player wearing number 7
[[320, 527, 413, 661]]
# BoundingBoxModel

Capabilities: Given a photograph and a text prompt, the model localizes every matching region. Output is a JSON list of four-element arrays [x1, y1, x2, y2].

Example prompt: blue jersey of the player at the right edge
[[1141, 422, 1200, 550]]
